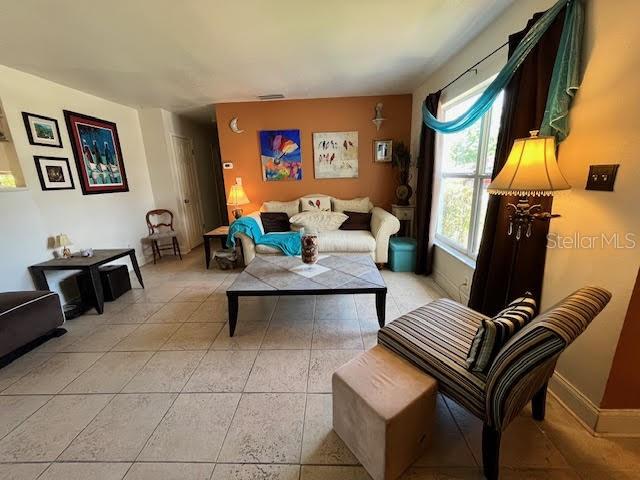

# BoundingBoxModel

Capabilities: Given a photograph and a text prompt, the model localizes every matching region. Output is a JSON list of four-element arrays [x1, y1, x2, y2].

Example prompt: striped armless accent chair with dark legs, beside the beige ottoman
[[378, 287, 611, 480]]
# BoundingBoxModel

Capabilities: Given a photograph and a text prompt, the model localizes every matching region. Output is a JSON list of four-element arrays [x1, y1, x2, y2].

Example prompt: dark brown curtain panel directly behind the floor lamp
[[469, 12, 564, 315]]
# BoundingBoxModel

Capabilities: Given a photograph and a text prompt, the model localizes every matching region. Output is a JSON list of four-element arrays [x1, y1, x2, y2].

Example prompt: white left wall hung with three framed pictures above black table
[[0, 66, 153, 300]]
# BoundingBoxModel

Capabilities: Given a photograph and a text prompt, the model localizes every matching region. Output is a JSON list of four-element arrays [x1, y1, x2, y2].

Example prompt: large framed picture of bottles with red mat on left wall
[[64, 110, 129, 195]]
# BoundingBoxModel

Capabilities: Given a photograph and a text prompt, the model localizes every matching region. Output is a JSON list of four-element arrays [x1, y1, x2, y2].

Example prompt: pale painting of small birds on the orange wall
[[313, 132, 358, 178]]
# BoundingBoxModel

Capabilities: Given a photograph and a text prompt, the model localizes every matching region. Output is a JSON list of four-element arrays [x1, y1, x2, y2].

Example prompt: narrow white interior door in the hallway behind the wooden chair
[[172, 135, 203, 249]]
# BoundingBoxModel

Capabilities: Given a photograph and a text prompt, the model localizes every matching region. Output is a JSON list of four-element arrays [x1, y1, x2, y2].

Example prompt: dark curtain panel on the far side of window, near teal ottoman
[[416, 91, 441, 275]]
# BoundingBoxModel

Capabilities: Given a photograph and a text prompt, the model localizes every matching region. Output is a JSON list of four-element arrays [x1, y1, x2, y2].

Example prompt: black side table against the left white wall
[[29, 248, 144, 315]]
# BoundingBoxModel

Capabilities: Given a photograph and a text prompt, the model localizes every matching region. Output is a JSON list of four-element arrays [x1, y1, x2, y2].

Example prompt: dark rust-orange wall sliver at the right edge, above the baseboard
[[601, 271, 640, 409]]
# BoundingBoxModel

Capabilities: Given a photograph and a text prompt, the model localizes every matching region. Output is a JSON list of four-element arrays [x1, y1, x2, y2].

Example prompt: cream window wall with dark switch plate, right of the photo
[[412, 0, 640, 413]]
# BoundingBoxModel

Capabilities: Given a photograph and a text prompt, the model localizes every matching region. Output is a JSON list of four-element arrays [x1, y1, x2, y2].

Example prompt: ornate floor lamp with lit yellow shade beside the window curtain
[[487, 130, 571, 305]]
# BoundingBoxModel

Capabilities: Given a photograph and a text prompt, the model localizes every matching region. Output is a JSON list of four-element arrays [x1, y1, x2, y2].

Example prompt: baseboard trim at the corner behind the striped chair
[[549, 372, 640, 437]]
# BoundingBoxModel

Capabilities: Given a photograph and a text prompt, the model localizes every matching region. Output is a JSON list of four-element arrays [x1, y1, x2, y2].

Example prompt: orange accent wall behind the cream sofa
[[215, 95, 411, 213]]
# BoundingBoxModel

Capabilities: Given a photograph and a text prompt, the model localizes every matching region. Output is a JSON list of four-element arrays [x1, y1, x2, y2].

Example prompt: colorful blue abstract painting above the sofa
[[260, 130, 302, 182]]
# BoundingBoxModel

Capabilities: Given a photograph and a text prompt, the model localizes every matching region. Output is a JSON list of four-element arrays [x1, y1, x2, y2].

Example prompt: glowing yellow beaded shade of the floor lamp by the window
[[487, 130, 571, 196]]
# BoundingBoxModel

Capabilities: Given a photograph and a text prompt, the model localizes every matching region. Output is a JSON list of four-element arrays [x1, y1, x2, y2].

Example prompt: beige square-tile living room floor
[[0, 249, 640, 480]]
